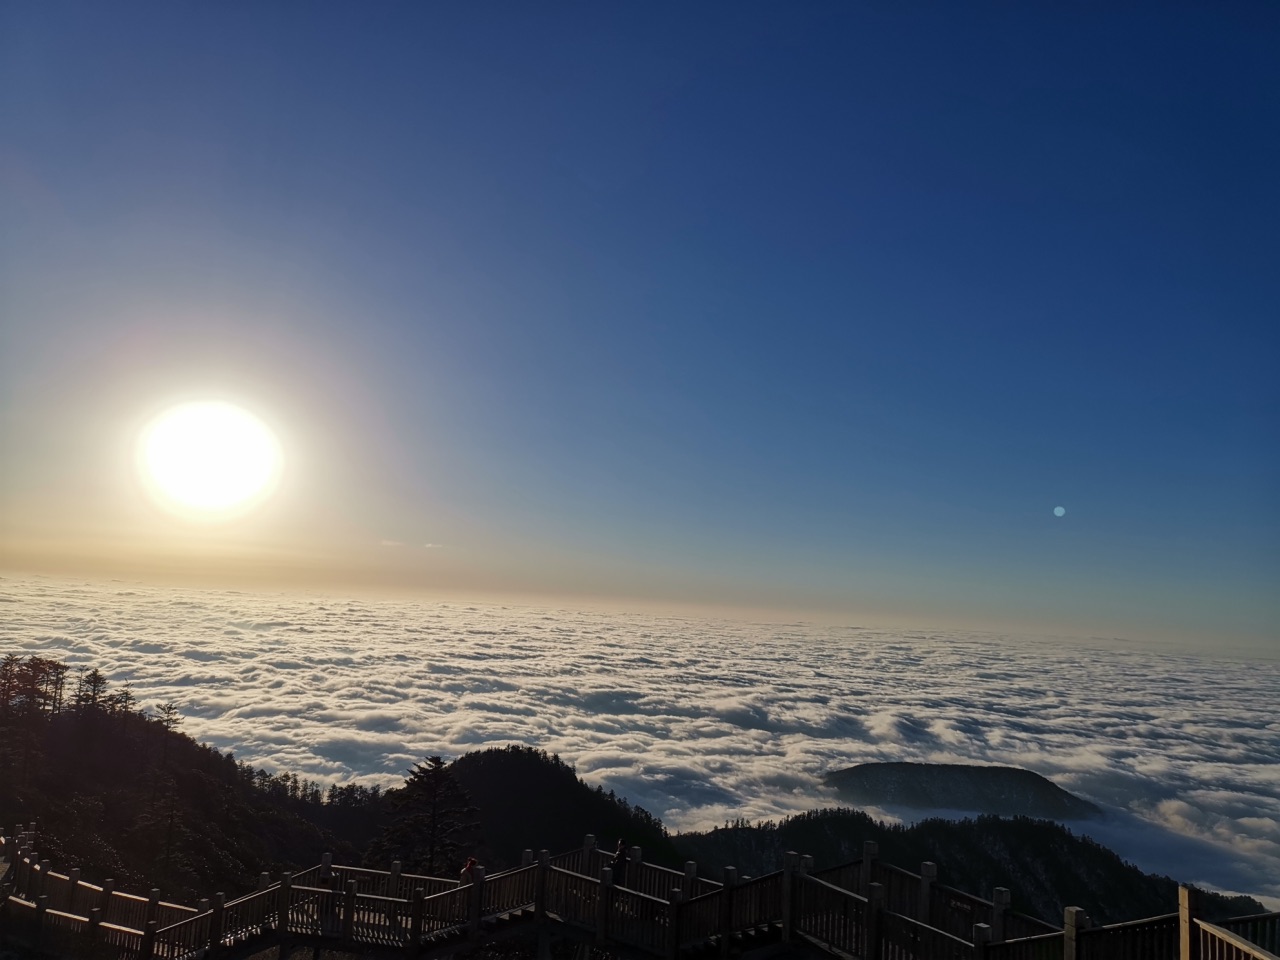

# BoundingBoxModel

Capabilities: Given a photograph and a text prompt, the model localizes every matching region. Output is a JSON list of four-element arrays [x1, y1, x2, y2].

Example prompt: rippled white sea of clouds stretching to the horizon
[[0, 577, 1280, 902]]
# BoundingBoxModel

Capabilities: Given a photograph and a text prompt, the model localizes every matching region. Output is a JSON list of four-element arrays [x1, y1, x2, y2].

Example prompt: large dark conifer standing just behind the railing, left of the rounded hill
[[366, 756, 479, 877]]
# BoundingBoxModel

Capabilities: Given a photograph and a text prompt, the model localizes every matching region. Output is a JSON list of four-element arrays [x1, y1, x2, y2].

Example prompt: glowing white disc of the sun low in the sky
[[138, 401, 283, 520]]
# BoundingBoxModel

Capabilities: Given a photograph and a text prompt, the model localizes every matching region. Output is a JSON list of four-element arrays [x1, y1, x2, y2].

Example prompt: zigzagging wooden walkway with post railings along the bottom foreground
[[0, 827, 1280, 960]]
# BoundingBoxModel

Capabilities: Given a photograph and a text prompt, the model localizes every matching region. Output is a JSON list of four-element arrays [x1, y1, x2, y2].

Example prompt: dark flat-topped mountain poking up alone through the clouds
[[826, 763, 1102, 820]]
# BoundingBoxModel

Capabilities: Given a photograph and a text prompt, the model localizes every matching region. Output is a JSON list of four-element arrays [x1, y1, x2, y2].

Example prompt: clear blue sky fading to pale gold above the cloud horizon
[[0, 3, 1280, 650]]
